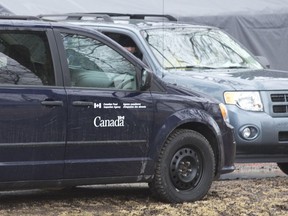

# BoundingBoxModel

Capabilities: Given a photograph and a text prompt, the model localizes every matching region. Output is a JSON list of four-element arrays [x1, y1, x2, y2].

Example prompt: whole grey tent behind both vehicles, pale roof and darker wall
[[0, 0, 288, 70]]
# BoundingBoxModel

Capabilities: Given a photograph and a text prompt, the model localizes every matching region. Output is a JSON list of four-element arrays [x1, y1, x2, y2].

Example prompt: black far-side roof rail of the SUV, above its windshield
[[88, 12, 177, 21]]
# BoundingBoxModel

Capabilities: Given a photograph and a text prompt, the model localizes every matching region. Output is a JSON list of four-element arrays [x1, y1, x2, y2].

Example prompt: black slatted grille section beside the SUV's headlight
[[270, 93, 288, 117]]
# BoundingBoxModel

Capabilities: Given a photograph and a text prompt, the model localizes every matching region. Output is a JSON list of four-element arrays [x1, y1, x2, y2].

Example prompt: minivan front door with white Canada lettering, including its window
[[58, 33, 153, 179]]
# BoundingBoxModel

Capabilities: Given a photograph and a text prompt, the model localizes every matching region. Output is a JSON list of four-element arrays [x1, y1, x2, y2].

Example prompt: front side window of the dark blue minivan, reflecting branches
[[62, 33, 137, 90]]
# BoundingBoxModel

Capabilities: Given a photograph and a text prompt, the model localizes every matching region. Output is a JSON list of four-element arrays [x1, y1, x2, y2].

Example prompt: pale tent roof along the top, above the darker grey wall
[[0, 0, 288, 16]]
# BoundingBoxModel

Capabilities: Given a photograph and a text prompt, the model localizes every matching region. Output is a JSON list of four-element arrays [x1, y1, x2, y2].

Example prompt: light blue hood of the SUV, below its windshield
[[162, 69, 288, 101]]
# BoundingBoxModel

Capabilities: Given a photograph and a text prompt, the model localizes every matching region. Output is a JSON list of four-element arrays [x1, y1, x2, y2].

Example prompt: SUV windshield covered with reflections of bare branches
[[143, 27, 262, 70]]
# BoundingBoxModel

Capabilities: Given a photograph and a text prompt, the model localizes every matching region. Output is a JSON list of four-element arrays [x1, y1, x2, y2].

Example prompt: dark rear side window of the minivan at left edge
[[0, 30, 55, 85]]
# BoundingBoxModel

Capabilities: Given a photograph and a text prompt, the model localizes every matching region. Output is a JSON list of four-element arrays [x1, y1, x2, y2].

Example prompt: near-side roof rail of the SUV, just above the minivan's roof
[[38, 13, 113, 22]]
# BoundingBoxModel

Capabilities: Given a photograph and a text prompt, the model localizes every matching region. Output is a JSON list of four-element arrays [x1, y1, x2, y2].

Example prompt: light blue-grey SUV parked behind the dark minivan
[[42, 14, 288, 174]]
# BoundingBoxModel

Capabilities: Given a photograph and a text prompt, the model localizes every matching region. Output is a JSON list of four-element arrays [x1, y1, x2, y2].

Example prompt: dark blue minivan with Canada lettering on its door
[[0, 17, 235, 202]]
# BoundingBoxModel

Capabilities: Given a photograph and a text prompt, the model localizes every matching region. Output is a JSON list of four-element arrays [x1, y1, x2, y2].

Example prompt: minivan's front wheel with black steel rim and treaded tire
[[149, 129, 215, 203]]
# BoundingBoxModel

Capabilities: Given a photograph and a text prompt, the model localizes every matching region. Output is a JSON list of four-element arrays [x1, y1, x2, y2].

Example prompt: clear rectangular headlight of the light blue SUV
[[224, 91, 263, 112]]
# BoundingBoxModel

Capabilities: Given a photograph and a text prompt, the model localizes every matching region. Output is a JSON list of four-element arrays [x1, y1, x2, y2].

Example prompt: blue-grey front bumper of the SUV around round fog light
[[227, 105, 288, 162]]
